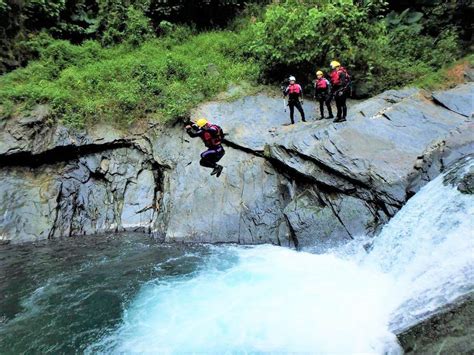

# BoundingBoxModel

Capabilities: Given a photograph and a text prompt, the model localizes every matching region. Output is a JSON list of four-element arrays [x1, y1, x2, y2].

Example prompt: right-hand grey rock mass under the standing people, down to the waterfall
[[188, 84, 474, 249]]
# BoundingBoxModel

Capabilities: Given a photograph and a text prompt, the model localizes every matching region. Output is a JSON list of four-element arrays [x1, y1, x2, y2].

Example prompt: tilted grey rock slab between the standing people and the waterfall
[[267, 87, 465, 208]]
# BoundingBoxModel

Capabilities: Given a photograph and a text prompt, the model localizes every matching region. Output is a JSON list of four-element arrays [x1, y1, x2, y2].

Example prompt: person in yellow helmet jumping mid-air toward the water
[[186, 118, 225, 177]]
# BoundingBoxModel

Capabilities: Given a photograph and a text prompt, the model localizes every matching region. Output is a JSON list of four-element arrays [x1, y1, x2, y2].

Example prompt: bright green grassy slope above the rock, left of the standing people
[[0, 31, 259, 127]]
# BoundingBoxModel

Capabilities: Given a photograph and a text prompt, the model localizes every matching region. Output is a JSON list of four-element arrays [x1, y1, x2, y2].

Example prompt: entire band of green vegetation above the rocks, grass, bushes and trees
[[0, 0, 472, 126]]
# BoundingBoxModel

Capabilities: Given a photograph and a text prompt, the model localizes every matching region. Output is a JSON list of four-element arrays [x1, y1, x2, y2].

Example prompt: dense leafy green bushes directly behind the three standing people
[[244, 0, 460, 96]]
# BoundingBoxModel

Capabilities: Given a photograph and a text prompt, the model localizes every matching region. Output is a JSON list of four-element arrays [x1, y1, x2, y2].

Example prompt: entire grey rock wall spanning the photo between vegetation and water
[[0, 84, 474, 248]]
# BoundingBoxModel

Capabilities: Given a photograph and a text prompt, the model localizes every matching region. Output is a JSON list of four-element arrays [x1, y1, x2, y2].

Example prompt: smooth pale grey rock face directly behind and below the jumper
[[152, 125, 290, 245]]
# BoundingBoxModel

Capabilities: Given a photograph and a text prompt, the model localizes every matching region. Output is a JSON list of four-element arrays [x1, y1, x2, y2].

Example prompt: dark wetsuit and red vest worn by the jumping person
[[186, 125, 225, 169]]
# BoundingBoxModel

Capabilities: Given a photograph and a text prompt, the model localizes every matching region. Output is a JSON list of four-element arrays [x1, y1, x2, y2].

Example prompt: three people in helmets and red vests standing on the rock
[[283, 60, 351, 124]]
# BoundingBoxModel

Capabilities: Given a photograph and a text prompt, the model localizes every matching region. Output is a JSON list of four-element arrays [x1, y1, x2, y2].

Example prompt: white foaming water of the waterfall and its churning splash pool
[[89, 160, 474, 354]]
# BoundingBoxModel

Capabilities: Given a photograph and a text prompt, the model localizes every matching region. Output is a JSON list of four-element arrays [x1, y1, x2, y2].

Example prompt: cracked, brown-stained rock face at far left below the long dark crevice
[[0, 148, 159, 242]]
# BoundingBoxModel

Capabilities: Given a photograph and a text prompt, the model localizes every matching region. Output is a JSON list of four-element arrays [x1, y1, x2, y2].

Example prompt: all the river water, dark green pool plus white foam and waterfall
[[0, 160, 474, 354]]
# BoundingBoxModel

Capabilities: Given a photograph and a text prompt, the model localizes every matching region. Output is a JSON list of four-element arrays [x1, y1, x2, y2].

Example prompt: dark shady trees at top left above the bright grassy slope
[[0, 0, 267, 73]]
